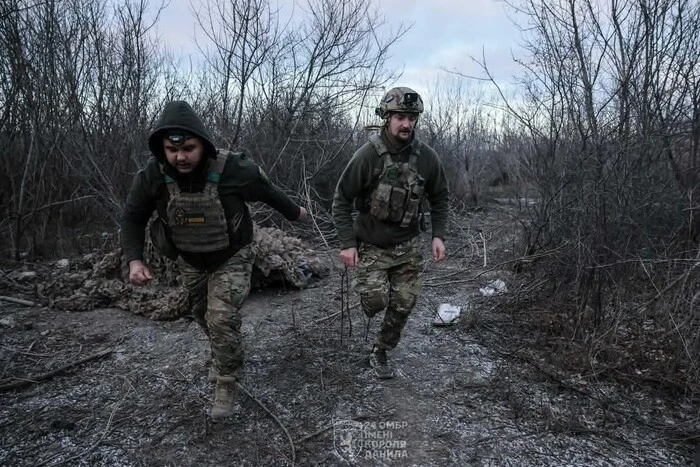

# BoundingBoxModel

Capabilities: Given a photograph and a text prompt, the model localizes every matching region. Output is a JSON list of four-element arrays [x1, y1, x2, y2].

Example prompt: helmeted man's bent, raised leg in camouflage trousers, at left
[[352, 243, 389, 318]]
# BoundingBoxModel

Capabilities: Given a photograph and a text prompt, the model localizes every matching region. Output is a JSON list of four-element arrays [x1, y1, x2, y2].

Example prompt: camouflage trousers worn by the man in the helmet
[[352, 237, 423, 349]]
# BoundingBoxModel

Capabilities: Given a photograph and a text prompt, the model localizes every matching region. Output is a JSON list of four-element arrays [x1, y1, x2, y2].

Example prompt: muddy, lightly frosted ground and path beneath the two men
[[0, 206, 697, 466]]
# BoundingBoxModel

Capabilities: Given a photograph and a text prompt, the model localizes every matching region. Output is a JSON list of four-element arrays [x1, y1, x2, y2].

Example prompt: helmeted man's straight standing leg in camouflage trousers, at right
[[376, 245, 423, 349]]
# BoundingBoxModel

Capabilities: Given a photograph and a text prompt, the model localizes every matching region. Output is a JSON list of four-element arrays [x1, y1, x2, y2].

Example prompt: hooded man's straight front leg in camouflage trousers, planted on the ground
[[206, 246, 255, 379]]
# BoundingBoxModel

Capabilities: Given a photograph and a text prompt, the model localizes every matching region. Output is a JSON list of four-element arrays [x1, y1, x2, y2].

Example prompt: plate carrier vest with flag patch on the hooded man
[[163, 152, 229, 253]]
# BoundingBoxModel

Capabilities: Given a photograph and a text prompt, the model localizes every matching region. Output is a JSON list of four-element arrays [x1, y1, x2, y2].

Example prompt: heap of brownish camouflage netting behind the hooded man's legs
[[36, 227, 328, 320]]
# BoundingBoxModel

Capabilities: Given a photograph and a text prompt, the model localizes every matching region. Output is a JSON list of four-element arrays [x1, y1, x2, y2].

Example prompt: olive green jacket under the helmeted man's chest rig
[[333, 132, 449, 249]]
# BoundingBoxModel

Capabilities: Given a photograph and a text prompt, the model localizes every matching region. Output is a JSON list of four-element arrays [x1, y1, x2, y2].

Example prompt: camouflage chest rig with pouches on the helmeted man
[[369, 136, 425, 227]]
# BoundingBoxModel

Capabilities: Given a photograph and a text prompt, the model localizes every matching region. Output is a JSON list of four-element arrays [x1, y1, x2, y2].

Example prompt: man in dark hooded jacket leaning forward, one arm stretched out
[[121, 101, 308, 419]]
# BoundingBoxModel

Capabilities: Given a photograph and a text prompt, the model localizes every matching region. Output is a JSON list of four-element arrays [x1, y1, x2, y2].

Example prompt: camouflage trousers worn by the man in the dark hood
[[178, 246, 255, 376]]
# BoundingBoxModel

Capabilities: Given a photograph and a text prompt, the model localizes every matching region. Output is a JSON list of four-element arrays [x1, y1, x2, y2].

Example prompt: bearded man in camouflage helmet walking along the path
[[333, 87, 449, 378]]
